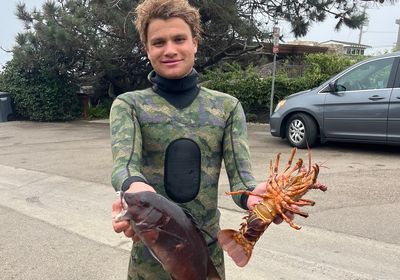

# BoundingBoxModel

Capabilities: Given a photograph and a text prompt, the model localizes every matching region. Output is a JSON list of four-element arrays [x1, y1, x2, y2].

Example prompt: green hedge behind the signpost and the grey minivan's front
[[202, 54, 365, 119]]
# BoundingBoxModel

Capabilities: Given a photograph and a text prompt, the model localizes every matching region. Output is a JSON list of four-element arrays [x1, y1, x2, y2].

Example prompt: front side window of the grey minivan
[[335, 57, 394, 91]]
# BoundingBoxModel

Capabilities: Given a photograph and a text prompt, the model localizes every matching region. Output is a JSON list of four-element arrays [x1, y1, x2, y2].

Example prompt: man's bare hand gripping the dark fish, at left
[[111, 182, 156, 241]]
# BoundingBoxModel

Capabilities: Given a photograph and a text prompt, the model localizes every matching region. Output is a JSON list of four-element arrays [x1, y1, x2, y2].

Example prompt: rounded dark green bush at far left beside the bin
[[0, 60, 80, 121]]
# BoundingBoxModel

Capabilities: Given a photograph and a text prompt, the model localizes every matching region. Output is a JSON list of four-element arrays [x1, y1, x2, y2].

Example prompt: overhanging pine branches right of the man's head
[[195, 0, 397, 70]]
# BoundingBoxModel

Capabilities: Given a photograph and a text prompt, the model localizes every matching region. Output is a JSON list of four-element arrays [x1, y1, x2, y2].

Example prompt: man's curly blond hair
[[134, 0, 202, 46]]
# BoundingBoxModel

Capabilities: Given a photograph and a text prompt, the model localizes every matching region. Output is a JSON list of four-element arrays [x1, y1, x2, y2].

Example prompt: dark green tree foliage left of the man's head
[[13, 0, 148, 99]]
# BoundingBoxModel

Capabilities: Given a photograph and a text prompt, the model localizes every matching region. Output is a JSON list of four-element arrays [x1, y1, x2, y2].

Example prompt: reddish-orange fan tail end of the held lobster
[[218, 229, 253, 267]]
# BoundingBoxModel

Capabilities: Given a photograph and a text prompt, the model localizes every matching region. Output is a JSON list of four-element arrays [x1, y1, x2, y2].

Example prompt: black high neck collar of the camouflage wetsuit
[[148, 69, 200, 109]]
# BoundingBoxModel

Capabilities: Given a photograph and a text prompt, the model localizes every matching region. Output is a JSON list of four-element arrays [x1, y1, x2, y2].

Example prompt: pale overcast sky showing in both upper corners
[[0, 0, 400, 67]]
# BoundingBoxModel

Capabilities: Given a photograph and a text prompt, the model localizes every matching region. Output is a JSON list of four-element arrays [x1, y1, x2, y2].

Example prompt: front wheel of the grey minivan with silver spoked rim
[[286, 113, 317, 149]]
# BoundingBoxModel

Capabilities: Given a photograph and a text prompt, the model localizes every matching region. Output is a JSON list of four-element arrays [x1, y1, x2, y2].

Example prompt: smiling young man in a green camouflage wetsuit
[[110, 0, 282, 280]]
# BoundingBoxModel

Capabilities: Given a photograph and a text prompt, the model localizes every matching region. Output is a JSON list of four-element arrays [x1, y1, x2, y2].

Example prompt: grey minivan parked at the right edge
[[270, 52, 400, 148]]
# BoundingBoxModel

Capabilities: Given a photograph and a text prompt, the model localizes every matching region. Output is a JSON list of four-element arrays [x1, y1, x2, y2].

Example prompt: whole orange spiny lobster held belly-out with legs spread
[[218, 148, 327, 267]]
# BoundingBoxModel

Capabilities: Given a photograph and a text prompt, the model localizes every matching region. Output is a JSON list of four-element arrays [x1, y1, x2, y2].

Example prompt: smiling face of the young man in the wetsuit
[[146, 17, 197, 79]]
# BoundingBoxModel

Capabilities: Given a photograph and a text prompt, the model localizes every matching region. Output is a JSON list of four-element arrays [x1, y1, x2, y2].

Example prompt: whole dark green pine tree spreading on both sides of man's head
[[2, 0, 396, 106]]
